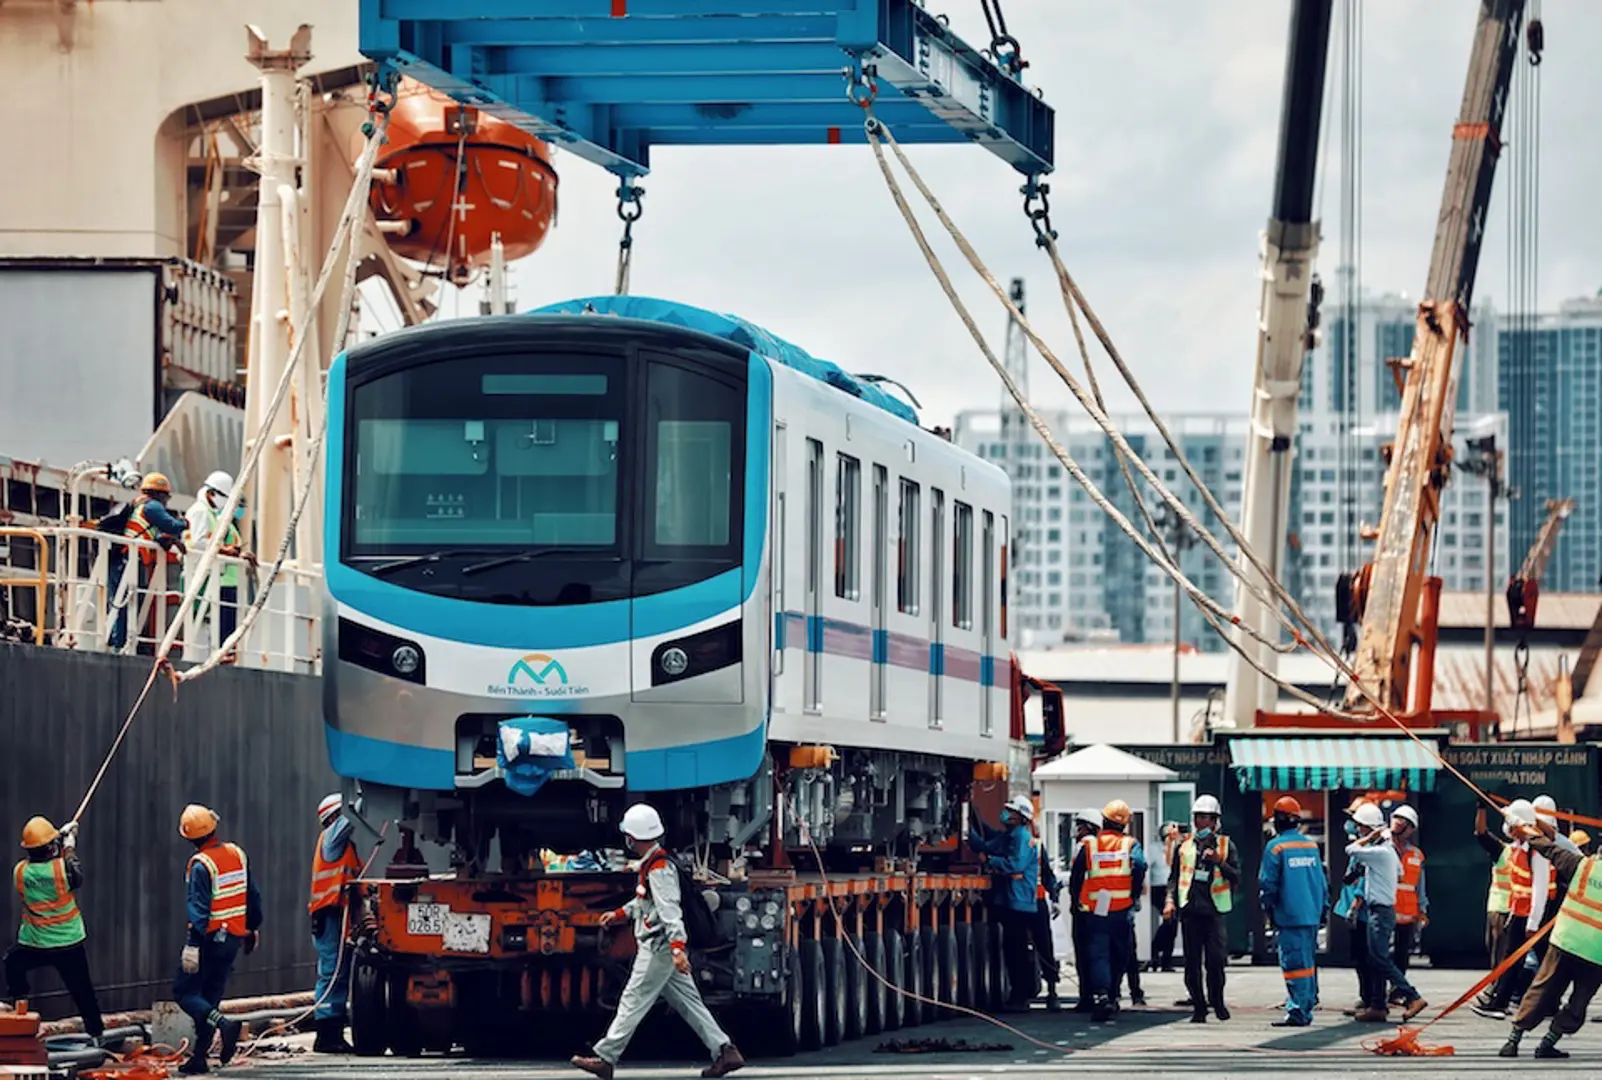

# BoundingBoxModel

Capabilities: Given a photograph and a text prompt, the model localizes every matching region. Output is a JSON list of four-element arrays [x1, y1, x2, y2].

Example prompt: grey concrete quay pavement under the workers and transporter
[[240, 966, 1602, 1080]]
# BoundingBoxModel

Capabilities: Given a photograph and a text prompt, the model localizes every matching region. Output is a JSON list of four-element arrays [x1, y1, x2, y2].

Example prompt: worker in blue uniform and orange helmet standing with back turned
[[1258, 795, 1330, 1027]]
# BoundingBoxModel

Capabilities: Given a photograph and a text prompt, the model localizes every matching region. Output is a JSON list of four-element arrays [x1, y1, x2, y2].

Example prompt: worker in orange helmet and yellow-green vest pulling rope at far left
[[5, 817, 106, 1040]]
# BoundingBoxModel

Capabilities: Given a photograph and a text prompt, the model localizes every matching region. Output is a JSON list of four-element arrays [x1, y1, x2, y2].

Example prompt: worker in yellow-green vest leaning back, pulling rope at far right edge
[[1498, 816, 1602, 1059]]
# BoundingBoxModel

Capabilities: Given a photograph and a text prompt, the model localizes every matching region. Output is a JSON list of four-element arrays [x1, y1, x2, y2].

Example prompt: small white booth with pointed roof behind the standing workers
[[1035, 744, 1195, 963]]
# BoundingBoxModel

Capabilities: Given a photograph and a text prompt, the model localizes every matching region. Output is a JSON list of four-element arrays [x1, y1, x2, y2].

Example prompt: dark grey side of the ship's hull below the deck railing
[[0, 644, 338, 1016]]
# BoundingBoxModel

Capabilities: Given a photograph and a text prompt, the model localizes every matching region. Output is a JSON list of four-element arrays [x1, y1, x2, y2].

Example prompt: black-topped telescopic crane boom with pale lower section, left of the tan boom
[[1224, 0, 1333, 727]]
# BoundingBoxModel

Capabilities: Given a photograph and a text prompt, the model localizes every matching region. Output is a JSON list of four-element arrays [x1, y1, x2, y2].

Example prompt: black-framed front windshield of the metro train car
[[341, 342, 745, 604]]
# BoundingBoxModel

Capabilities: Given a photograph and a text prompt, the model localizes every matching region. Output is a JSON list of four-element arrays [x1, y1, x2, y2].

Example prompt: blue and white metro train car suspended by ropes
[[324, 296, 1016, 865]]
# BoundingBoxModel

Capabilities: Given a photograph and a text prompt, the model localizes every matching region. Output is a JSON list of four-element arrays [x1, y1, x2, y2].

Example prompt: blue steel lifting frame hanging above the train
[[360, 0, 1054, 179]]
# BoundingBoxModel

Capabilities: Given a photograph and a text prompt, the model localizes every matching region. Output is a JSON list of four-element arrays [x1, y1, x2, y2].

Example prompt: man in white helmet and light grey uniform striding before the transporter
[[572, 803, 745, 1080]]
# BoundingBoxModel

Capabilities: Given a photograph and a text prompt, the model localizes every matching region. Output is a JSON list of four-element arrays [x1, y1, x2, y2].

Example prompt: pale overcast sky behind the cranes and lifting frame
[[416, 0, 1602, 425]]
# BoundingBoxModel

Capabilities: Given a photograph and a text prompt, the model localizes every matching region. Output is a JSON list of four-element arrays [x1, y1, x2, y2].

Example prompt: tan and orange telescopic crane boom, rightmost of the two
[[1346, 0, 1525, 711]]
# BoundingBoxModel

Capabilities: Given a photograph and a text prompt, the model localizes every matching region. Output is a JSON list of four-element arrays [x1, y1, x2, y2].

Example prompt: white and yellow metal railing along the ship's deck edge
[[0, 526, 322, 675]]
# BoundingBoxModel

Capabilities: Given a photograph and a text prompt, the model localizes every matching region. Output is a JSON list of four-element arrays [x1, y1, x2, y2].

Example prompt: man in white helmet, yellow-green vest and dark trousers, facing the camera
[[1163, 795, 1240, 1024]]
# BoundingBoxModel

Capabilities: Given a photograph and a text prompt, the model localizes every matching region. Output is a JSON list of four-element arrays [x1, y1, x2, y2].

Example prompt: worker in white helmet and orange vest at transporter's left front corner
[[306, 793, 362, 1054]]
